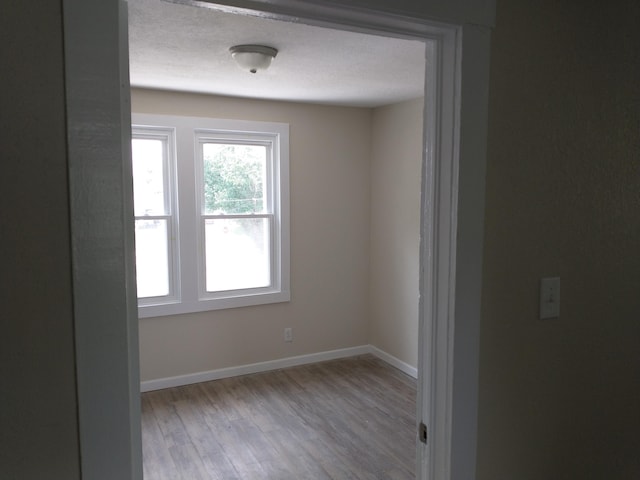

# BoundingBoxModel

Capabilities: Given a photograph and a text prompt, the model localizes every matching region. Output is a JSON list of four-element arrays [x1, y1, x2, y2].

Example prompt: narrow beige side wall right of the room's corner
[[369, 99, 424, 367]]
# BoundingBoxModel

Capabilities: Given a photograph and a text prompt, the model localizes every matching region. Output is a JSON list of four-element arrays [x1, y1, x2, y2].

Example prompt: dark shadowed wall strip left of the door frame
[[0, 2, 80, 480]]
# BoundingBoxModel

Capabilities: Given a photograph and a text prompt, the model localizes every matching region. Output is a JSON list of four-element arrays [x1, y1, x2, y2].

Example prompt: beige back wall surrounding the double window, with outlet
[[132, 89, 371, 381]]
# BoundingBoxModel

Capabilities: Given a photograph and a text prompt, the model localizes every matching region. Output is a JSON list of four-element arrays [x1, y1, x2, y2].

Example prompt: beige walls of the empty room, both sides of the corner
[[132, 89, 423, 381]]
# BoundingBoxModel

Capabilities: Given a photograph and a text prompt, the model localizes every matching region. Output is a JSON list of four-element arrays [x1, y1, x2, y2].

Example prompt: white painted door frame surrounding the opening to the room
[[63, 0, 490, 480]]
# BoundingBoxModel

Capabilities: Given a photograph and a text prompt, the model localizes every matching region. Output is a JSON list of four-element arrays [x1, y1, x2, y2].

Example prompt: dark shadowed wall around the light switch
[[477, 0, 640, 480]]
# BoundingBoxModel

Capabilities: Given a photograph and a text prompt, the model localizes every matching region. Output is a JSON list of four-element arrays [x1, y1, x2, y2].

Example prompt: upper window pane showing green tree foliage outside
[[202, 143, 267, 214]]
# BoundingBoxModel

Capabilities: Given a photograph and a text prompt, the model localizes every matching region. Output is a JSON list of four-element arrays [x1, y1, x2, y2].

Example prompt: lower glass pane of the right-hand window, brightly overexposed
[[205, 218, 271, 292]]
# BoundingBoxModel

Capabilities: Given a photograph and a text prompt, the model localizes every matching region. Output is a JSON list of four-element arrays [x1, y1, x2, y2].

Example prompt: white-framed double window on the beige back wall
[[132, 114, 290, 317]]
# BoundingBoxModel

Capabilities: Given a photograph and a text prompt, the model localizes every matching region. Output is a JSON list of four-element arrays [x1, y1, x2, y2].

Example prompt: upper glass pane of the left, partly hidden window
[[131, 138, 169, 217]]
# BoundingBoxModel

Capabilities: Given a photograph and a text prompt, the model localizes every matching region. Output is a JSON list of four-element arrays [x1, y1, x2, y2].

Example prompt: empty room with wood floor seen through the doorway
[[129, 0, 426, 479]]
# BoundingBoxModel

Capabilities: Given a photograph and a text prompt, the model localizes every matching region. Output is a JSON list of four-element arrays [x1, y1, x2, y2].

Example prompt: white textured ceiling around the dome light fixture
[[128, 0, 425, 107]]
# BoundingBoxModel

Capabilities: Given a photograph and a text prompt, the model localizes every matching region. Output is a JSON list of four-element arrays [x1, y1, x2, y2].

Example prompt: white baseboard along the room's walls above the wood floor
[[140, 345, 418, 392]]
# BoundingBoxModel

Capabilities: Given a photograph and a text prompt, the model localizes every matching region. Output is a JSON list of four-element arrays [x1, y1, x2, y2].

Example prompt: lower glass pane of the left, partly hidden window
[[136, 220, 169, 298]]
